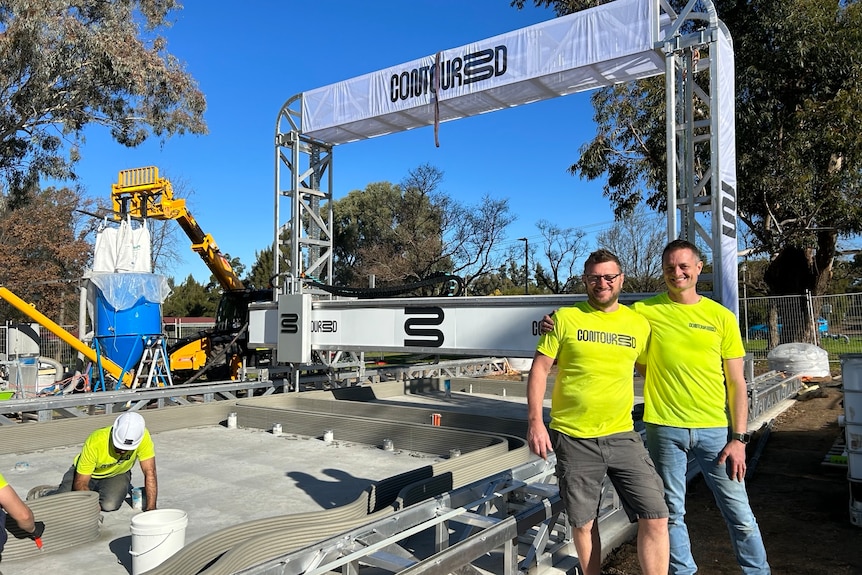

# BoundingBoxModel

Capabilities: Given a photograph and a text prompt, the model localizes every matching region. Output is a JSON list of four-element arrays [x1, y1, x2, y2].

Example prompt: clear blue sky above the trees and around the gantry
[[71, 0, 613, 282]]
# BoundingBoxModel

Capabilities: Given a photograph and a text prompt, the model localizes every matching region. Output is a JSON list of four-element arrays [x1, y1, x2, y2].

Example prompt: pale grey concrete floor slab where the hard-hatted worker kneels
[[0, 420, 440, 575]]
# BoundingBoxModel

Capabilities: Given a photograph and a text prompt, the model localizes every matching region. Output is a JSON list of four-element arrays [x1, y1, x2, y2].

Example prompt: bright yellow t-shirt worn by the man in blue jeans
[[632, 293, 745, 427]]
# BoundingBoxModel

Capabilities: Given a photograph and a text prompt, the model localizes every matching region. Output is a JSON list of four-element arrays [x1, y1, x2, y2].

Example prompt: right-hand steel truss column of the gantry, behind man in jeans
[[657, 0, 727, 300]]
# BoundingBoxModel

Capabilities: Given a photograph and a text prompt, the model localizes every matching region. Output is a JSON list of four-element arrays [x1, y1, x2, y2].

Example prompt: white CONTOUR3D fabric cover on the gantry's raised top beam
[[302, 0, 664, 145]]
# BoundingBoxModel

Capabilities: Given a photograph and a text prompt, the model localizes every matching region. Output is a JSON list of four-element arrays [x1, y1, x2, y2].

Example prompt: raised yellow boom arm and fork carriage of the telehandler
[[111, 166, 245, 291]]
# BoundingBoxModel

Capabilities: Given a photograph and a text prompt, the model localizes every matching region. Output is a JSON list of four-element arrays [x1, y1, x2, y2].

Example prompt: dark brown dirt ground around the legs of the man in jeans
[[602, 381, 862, 575]]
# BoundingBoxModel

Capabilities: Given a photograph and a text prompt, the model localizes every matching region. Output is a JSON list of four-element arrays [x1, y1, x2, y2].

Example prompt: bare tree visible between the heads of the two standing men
[[596, 207, 667, 293]]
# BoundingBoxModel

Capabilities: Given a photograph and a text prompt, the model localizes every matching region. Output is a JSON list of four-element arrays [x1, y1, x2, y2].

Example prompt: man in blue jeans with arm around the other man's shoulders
[[541, 240, 770, 575]]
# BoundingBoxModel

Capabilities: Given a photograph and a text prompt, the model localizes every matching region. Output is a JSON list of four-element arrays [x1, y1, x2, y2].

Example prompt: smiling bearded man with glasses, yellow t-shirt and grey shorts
[[527, 250, 668, 575]]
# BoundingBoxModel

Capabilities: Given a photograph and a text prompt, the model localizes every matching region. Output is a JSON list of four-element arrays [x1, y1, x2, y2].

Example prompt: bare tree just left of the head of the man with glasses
[[536, 220, 587, 293]]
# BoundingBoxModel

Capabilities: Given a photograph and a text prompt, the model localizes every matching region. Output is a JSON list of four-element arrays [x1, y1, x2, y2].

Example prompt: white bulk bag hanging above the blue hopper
[[93, 220, 153, 273]]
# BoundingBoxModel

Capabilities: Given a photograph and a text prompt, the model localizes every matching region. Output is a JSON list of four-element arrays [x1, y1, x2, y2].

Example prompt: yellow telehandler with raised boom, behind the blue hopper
[[111, 166, 272, 381]]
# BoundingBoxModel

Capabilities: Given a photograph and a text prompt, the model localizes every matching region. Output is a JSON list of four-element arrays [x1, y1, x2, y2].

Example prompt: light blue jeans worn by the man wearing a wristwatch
[[646, 423, 770, 575]]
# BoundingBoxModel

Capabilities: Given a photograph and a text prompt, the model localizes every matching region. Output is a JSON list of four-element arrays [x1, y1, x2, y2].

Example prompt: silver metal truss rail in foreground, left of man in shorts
[[236, 456, 629, 575]]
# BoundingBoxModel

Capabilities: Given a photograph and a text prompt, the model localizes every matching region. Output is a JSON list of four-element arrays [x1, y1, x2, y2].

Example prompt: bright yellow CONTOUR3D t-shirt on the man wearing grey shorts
[[536, 302, 650, 438]]
